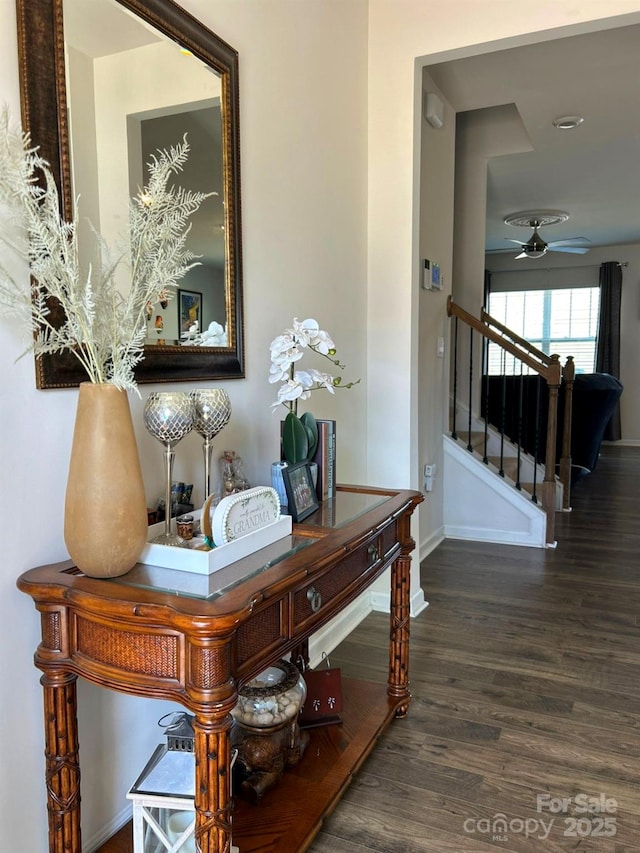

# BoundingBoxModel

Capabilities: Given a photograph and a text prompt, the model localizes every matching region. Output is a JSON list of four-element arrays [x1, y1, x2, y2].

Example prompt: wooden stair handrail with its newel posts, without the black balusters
[[447, 296, 575, 544]]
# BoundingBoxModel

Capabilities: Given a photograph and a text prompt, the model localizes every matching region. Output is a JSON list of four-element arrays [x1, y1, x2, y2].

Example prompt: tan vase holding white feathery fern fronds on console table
[[0, 108, 211, 577]]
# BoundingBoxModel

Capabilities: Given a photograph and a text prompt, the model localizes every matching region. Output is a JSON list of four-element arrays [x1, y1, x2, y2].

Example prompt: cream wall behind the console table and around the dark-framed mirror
[[0, 0, 640, 853]]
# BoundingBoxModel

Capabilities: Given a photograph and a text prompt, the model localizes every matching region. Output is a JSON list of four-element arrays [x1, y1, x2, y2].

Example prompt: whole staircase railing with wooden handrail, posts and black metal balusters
[[447, 297, 575, 544]]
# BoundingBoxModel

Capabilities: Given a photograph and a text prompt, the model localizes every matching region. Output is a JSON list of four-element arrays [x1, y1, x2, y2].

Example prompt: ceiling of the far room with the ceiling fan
[[427, 25, 640, 251]]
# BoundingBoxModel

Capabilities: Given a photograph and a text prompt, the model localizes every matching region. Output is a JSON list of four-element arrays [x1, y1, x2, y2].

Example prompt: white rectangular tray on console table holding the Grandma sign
[[138, 510, 292, 575]]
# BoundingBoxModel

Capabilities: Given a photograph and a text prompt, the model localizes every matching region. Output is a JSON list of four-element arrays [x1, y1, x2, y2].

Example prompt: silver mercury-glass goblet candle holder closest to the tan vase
[[144, 391, 194, 548]]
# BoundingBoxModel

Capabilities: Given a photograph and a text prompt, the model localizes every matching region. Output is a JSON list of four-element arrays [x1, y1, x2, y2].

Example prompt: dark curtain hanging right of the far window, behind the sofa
[[596, 261, 622, 441]]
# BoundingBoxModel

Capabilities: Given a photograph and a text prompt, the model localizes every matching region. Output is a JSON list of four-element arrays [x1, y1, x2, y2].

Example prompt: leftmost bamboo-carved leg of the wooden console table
[[40, 671, 82, 853]]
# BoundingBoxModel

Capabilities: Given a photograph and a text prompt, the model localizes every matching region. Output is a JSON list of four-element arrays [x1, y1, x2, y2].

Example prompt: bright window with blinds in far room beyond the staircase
[[487, 287, 600, 374]]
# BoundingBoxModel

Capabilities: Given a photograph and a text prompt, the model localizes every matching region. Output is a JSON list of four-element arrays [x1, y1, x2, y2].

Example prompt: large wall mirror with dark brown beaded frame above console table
[[16, 0, 244, 388]]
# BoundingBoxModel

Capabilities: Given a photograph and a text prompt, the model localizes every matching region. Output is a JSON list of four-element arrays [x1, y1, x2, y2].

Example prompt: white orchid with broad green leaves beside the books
[[269, 318, 360, 465]]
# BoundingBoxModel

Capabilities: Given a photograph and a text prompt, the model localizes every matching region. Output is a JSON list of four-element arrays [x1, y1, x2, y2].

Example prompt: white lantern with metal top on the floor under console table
[[127, 713, 239, 853]]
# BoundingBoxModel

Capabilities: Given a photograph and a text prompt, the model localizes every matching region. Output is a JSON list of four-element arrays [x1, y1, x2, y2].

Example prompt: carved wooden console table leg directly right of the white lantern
[[193, 714, 232, 853]]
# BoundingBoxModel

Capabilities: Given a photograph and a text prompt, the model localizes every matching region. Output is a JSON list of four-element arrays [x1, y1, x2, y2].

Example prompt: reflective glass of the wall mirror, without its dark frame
[[63, 0, 228, 346]]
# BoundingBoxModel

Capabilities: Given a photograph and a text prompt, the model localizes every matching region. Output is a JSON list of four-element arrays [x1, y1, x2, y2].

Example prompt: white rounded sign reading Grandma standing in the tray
[[212, 486, 280, 545]]
